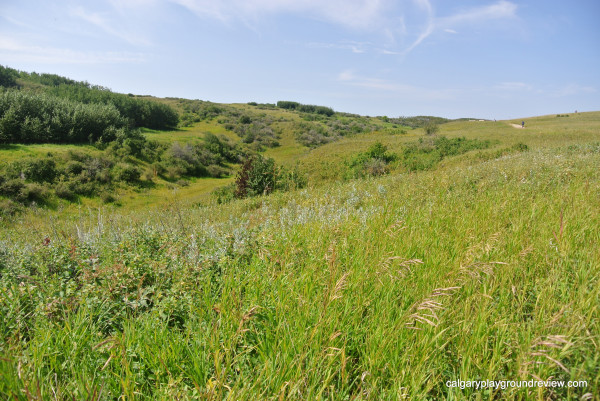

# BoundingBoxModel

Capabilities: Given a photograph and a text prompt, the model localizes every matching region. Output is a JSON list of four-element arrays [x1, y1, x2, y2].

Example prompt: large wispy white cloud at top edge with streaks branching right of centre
[[166, 0, 517, 55]]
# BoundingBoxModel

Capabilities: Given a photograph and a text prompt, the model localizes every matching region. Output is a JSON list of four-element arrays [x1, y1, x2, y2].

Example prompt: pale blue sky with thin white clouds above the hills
[[0, 0, 600, 119]]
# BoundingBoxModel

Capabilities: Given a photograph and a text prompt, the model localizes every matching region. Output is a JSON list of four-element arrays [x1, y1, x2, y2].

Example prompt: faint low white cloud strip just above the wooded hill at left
[[0, 37, 146, 64]]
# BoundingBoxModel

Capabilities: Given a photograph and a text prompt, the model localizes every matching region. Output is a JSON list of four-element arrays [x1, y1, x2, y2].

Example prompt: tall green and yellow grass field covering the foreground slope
[[0, 110, 600, 400]]
